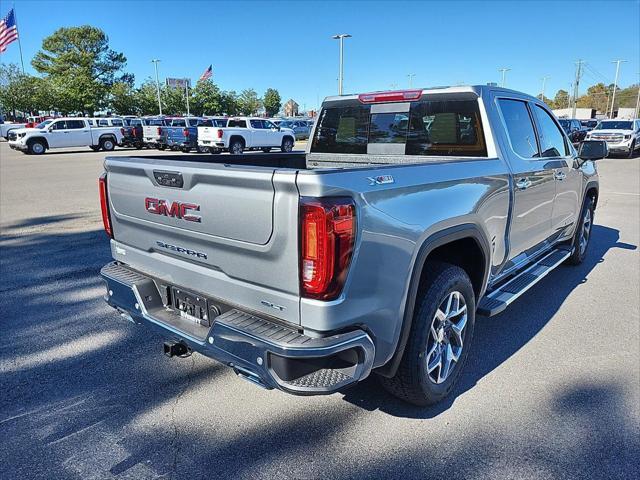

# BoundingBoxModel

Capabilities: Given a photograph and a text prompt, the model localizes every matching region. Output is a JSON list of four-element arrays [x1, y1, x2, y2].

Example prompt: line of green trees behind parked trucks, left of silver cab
[[0, 25, 282, 116]]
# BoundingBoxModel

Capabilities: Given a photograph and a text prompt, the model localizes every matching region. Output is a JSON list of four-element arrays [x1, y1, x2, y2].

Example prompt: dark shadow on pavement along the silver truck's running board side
[[344, 225, 637, 418]]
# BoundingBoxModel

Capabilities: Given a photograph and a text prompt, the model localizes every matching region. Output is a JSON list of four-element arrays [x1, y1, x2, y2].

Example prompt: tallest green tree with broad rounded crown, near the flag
[[31, 25, 133, 113]]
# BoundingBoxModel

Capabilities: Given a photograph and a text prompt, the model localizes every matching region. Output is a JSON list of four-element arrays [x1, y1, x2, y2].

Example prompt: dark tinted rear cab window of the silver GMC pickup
[[311, 100, 487, 157]]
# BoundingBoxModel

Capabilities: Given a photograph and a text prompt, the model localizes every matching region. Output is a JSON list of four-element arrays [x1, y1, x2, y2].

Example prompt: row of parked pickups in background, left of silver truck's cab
[[7, 117, 311, 154]]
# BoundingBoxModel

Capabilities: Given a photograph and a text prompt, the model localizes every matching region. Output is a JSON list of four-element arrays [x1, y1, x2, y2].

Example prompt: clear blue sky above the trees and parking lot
[[0, 0, 640, 108]]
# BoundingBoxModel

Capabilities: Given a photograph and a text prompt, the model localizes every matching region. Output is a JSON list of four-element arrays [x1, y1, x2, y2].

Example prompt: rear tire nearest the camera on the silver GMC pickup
[[380, 262, 476, 406]]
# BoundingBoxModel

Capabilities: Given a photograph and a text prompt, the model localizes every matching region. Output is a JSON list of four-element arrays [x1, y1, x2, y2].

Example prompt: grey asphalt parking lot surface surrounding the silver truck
[[0, 143, 640, 480]]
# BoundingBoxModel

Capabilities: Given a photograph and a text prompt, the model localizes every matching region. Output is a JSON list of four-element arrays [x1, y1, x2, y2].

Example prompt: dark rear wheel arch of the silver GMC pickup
[[376, 223, 491, 377]]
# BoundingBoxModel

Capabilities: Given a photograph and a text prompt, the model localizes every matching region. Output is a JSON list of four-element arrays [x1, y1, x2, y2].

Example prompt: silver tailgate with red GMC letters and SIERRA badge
[[105, 157, 299, 323]]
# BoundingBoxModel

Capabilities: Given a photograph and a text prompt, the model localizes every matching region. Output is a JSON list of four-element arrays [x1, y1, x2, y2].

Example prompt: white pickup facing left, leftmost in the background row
[[9, 118, 122, 155]]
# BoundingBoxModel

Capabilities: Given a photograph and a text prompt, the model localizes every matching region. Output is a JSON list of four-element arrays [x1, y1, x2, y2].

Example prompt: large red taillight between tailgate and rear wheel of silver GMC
[[300, 197, 356, 300]]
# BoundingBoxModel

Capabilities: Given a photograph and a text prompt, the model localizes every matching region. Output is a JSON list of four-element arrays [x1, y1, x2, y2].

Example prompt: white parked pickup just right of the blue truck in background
[[198, 117, 295, 155]]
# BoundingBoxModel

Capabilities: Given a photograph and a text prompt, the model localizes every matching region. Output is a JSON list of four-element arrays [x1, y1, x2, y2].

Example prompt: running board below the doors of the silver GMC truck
[[477, 249, 571, 317]]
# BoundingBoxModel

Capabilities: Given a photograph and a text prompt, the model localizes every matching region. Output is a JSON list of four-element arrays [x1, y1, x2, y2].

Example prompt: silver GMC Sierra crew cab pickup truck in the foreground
[[99, 86, 608, 405]]
